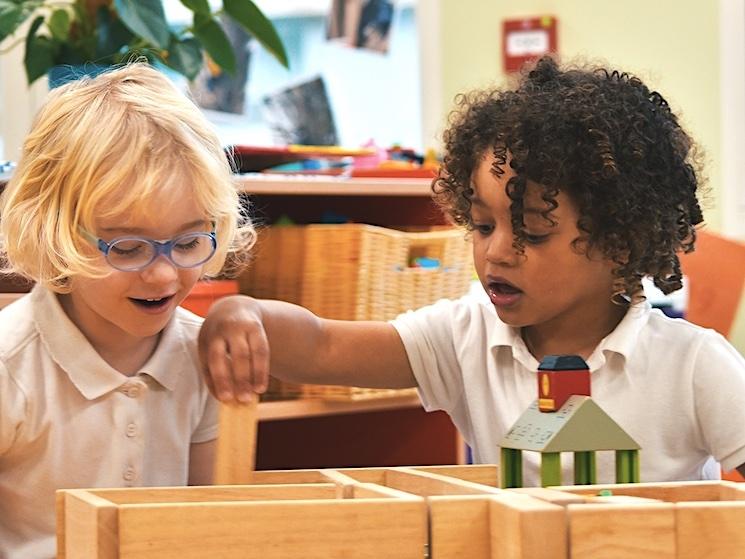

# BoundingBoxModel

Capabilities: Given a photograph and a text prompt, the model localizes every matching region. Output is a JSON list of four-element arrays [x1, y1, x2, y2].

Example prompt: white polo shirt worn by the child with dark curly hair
[[392, 296, 745, 485]]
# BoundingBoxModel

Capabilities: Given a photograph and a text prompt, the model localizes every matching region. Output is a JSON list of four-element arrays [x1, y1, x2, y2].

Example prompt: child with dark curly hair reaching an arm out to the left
[[200, 58, 745, 485]]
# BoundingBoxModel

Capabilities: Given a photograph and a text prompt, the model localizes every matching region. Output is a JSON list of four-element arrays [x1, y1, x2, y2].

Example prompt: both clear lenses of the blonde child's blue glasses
[[107, 233, 215, 270]]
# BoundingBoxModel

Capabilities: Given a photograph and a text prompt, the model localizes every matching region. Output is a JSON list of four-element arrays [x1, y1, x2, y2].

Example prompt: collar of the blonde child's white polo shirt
[[31, 285, 186, 400]]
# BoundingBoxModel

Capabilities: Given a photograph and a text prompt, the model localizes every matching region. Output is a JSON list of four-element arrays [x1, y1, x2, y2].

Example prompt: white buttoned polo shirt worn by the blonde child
[[0, 286, 217, 559]]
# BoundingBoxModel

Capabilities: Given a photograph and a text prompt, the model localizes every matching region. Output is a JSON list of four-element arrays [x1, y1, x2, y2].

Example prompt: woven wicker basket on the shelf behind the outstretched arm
[[240, 223, 473, 399]]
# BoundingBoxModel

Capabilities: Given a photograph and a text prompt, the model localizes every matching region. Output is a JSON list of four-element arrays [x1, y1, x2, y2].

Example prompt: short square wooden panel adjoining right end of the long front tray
[[428, 495, 492, 559]]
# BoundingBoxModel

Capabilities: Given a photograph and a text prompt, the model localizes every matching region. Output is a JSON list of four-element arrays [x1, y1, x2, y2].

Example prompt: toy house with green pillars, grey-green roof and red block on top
[[499, 355, 639, 488]]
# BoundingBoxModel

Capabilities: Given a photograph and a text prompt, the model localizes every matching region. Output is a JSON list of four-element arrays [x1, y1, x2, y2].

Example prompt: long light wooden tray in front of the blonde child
[[58, 483, 427, 559]]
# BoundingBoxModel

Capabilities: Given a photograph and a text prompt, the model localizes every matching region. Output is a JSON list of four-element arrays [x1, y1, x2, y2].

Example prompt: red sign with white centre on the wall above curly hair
[[502, 16, 557, 72]]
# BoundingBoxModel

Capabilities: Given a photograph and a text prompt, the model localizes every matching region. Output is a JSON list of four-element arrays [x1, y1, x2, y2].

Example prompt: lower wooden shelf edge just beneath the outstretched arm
[[259, 394, 422, 421]]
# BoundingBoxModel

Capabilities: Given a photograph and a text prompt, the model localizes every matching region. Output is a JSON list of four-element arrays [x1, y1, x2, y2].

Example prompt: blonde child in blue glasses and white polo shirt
[[0, 64, 254, 559]]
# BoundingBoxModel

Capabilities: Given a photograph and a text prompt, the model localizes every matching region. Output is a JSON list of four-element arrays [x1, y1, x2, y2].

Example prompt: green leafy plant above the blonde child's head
[[0, 0, 287, 84]]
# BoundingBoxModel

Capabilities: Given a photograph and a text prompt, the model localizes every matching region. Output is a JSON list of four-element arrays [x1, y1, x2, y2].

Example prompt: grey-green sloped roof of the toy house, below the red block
[[499, 395, 639, 452]]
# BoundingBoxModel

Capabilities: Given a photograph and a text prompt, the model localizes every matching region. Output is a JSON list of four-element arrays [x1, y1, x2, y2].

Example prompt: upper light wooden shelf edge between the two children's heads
[[232, 177, 432, 198]]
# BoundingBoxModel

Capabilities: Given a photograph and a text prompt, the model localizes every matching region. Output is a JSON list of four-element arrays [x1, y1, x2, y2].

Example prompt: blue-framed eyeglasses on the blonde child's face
[[78, 227, 217, 272]]
